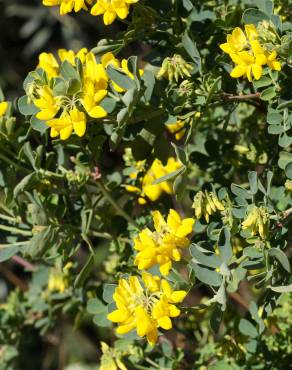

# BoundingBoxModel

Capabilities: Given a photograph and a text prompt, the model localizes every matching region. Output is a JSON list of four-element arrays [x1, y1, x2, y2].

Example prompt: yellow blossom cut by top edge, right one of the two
[[91, 0, 139, 26]]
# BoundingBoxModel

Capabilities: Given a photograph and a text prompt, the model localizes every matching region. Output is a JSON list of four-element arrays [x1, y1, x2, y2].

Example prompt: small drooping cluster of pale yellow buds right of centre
[[192, 190, 224, 223]]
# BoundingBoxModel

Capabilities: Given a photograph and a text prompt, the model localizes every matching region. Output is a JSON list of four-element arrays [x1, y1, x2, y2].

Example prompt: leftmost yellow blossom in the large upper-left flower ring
[[33, 86, 60, 121]]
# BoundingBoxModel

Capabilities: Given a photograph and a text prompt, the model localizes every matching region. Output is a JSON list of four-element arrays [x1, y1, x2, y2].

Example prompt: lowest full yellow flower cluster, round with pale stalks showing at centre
[[108, 272, 186, 345]]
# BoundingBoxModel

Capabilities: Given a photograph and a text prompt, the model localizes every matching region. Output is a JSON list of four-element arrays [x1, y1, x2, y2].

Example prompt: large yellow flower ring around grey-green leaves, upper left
[[25, 48, 133, 140]]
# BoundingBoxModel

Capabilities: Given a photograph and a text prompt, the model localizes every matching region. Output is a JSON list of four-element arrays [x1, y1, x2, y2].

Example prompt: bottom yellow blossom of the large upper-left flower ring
[[46, 107, 86, 140]]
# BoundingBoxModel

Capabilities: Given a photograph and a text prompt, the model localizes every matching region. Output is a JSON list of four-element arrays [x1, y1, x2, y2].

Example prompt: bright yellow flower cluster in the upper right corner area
[[220, 24, 281, 81]]
